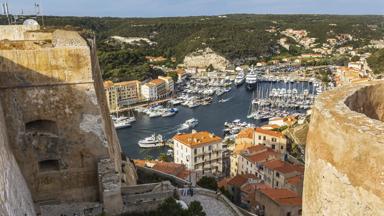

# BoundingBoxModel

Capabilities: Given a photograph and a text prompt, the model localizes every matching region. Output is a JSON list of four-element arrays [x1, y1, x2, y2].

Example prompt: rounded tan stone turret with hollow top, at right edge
[[303, 81, 384, 215]]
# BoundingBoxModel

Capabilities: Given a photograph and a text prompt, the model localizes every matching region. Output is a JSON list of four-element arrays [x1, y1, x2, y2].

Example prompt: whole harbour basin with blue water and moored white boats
[[117, 79, 316, 159]]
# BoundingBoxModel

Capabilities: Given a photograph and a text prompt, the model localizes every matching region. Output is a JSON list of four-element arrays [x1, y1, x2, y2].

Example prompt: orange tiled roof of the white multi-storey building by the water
[[173, 131, 221, 147]]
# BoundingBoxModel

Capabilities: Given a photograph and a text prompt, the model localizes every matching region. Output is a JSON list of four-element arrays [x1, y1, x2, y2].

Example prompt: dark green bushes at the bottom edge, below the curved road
[[122, 198, 206, 216]]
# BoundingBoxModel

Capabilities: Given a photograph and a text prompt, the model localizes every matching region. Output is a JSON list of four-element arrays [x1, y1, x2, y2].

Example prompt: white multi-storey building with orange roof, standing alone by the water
[[173, 131, 225, 176]]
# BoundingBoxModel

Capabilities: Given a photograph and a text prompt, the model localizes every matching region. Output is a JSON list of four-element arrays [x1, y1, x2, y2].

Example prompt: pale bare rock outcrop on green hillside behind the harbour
[[184, 48, 229, 71]]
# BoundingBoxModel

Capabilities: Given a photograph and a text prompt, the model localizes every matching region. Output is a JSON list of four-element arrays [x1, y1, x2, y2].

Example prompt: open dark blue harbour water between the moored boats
[[117, 82, 308, 159]]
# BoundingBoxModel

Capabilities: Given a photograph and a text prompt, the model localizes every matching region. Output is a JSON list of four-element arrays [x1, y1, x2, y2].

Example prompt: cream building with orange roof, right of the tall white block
[[254, 128, 288, 153]]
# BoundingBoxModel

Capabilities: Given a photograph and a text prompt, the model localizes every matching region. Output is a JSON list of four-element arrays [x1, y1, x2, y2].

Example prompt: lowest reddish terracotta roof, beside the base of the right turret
[[259, 188, 302, 206]]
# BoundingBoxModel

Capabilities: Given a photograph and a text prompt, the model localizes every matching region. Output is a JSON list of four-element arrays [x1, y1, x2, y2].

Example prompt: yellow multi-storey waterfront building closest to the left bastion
[[104, 80, 141, 111]]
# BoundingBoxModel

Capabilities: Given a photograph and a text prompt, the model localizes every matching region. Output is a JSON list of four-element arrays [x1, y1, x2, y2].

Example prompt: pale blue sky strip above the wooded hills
[[4, 0, 384, 17]]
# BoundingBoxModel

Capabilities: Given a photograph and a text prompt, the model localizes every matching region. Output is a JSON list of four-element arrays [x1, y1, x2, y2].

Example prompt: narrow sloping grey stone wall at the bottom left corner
[[0, 101, 35, 216]]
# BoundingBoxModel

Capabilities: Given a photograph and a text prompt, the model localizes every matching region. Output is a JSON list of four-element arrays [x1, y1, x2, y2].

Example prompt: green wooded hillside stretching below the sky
[[0, 14, 384, 80]]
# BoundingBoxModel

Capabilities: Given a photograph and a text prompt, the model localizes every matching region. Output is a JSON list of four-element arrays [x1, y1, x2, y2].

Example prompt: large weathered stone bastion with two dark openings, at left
[[0, 24, 136, 215]]
